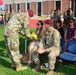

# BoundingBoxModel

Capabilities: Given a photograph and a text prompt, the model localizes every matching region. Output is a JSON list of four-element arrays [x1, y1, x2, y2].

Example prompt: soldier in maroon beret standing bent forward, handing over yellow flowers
[[4, 9, 33, 71]]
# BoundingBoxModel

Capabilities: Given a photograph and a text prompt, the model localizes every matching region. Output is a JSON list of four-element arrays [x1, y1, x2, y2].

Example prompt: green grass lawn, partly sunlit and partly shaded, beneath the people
[[0, 25, 76, 75]]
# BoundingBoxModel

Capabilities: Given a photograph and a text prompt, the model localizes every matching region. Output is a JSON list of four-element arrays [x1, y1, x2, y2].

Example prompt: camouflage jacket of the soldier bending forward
[[4, 13, 32, 38]]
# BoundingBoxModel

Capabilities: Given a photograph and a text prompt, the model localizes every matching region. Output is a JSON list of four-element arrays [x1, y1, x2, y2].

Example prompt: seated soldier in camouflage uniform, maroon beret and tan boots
[[32, 19, 61, 75]]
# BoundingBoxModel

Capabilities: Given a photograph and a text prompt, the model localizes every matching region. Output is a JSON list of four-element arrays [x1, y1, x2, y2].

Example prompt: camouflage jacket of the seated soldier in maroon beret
[[39, 28, 61, 52]]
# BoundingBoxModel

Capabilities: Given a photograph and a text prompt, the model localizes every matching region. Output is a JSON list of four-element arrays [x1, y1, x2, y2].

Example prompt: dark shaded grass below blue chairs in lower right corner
[[57, 61, 76, 75]]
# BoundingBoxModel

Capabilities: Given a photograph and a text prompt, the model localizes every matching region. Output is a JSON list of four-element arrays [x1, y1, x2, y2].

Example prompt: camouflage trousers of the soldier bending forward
[[4, 36, 21, 64]]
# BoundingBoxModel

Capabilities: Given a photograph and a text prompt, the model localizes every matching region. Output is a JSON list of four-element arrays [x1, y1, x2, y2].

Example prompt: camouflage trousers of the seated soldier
[[32, 46, 60, 70]]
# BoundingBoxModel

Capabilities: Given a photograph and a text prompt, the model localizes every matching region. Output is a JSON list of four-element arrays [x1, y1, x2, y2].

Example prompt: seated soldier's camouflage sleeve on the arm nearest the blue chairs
[[46, 31, 60, 52]]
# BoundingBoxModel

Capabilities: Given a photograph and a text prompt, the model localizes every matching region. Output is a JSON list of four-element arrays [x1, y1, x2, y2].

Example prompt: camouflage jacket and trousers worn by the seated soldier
[[32, 28, 61, 70]]
